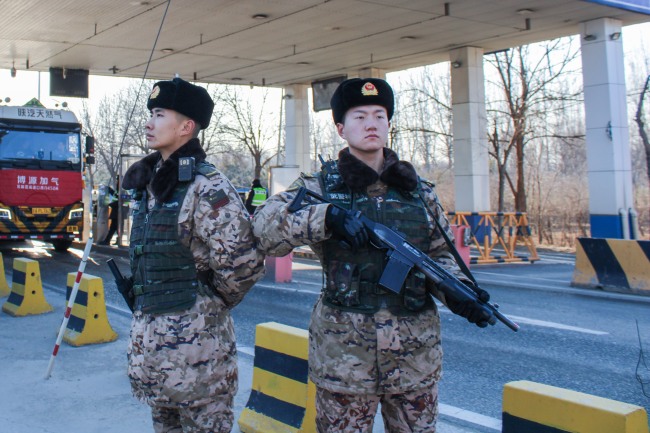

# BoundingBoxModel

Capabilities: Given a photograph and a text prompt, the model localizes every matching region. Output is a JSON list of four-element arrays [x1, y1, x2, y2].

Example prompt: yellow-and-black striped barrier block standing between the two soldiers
[[238, 322, 316, 433]]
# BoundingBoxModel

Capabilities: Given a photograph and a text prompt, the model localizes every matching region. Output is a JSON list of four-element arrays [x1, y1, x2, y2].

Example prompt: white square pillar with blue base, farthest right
[[580, 18, 634, 239]]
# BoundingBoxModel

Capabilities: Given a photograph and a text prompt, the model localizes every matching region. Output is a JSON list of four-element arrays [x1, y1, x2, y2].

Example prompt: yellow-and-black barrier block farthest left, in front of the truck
[[2, 258, 52, 316]]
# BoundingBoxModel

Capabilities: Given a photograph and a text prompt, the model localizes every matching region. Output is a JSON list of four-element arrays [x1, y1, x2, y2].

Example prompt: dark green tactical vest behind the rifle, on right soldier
[[320, 164, 434, 315]]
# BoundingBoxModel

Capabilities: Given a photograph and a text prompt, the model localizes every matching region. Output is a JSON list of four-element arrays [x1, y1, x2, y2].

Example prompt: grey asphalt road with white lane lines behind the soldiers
[[0, 242, 650, 428]]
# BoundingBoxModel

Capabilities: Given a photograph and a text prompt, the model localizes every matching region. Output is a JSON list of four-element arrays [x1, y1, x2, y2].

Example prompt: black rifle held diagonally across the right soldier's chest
[[288, 187, 519, 332]]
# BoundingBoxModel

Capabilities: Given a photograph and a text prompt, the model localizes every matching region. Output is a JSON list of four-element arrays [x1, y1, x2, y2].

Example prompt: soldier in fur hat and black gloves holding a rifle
[[253, 78, 491, 433]]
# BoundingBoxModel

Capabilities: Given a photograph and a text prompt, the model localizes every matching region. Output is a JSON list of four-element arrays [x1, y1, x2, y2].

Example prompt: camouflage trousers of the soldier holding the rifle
[[316, 384, 438, 433]]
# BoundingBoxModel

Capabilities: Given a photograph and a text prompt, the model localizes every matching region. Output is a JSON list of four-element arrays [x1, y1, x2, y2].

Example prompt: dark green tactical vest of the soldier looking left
[[129, 163, 215, 314]]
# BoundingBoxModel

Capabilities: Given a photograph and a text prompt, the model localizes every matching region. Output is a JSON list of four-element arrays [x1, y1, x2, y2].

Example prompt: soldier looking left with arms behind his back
[[123, 78, 264, 433]]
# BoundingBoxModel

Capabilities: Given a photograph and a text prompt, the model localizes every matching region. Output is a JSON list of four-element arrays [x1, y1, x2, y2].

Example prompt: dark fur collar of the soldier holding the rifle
[[338, 147, 418, 191]]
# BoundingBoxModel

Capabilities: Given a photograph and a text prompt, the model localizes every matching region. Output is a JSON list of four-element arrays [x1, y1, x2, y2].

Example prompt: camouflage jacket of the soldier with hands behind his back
[[124, 140, 264, 406]]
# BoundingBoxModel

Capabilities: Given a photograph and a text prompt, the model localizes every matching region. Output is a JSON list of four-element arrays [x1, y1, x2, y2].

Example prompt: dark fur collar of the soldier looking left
[[122, 138, 206, 202]]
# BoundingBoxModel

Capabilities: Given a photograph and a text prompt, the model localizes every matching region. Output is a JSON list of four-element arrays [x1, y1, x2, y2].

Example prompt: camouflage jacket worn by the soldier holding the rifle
[[253, 149, 460, 394]]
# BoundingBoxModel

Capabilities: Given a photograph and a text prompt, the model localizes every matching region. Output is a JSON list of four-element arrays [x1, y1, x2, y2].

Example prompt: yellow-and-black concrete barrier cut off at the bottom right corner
[[501, 380, 648, 433]]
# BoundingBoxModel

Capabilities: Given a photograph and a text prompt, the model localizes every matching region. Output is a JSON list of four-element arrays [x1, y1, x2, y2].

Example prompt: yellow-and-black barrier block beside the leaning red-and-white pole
[[63, 272, 117, 346]]
